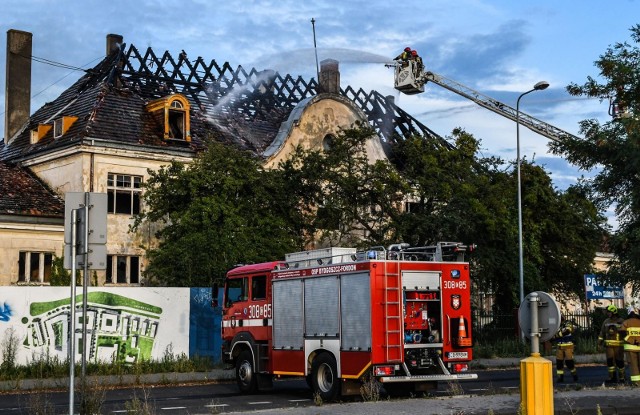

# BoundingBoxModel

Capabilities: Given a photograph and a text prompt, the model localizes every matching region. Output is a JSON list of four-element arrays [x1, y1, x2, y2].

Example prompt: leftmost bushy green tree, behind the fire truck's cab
[[133, 141, 302, 286]]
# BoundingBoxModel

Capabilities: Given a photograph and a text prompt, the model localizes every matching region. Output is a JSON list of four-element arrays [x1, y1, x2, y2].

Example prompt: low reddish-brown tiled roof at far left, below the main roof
[[0, 161, 64, 219]]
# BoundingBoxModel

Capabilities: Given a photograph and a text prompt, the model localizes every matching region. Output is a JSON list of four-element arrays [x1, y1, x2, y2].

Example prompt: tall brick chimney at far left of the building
[[4, 29, 33, 145]]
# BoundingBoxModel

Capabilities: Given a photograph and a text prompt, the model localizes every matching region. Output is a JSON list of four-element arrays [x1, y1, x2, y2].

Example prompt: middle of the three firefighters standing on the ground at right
[[598, 304, 624, 383]]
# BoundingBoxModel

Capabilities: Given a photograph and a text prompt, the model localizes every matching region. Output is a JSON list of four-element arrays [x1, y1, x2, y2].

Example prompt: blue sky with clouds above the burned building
[[0, 0, 640, 226]]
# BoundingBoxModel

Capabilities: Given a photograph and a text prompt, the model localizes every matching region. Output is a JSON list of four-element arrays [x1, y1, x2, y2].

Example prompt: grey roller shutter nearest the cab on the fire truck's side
[[273, 279, 303, 350]]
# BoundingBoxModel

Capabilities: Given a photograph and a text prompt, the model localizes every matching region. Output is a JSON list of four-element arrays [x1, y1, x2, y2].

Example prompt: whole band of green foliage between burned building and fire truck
[[133, 124, 604, 314]]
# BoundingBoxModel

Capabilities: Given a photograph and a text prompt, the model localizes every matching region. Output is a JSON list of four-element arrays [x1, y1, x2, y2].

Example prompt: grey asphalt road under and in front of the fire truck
[[0, 364, 640, 415]]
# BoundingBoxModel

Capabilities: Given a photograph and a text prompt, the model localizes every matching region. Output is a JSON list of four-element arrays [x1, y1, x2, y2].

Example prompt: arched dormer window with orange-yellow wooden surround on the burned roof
[[147, 94, 191, 141]]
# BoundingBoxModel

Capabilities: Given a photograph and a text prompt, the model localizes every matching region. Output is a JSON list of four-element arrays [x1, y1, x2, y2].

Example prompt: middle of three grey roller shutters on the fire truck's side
[[304, 275, 340, 338]]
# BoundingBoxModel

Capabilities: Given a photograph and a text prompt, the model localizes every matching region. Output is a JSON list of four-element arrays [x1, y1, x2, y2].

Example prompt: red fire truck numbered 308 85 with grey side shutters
[[213, 242, 477, 400]]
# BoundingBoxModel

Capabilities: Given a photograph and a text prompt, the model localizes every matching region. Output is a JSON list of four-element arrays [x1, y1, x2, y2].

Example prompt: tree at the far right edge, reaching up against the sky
[[551, 25, 640, 291]]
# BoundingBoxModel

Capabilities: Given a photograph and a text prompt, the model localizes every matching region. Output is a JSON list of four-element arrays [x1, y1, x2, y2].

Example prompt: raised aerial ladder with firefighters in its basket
[[388, 60, 577, 141]]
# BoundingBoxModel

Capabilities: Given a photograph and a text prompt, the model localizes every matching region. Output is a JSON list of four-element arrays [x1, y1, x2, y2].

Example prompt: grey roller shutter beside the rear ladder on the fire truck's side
[[340, 273, 371, 351]]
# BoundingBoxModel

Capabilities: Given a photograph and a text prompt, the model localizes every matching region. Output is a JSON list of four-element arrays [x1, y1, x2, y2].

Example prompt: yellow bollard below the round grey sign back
[[520, 353, 553, 415]]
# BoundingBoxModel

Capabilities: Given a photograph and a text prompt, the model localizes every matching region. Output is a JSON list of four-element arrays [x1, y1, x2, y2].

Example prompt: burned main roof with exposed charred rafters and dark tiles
[[0, 44, 448, 161]]
